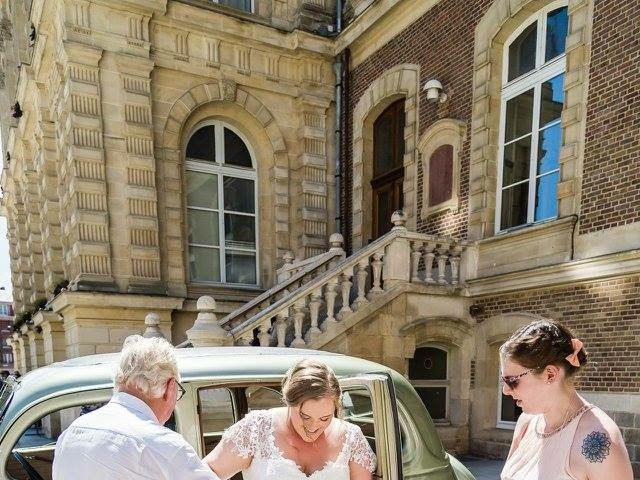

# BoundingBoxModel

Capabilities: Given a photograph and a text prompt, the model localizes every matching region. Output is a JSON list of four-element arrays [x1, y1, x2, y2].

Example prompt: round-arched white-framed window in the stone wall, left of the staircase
[[185, 121, 258, 285]]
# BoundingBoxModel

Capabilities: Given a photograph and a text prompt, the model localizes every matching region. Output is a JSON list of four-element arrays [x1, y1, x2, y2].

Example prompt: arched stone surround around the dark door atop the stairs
[[352, 64, 420, 249]]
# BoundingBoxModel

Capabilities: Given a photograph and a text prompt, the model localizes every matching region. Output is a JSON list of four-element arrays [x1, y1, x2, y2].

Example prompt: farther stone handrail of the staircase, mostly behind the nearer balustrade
[[220, 233, 344, 328]]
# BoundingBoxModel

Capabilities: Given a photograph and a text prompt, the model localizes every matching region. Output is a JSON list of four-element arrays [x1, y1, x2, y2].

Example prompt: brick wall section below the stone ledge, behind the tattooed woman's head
[[475, 275, 640, 393]]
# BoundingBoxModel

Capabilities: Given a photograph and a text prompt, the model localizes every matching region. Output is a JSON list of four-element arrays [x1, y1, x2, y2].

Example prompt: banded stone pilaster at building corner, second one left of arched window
[[55, 41, 116, 292]]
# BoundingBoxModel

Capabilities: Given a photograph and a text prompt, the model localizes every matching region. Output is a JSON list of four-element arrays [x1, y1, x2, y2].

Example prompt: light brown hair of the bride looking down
[[282, 359, 342, 416]]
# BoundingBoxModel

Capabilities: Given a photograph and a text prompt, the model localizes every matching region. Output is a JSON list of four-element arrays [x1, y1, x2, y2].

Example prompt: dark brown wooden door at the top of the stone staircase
[[371, 99, 404, 240]]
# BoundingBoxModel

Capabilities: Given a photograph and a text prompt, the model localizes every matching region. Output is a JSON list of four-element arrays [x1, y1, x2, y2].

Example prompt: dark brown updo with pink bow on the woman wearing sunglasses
[[500, 320, 588, 377]]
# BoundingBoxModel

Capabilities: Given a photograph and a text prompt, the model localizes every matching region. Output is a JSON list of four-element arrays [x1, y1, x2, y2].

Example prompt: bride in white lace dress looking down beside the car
[[204, 360, 376, 480]]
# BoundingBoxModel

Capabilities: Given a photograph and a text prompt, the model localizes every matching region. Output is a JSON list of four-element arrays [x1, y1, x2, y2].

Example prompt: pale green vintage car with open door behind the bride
[[0, 347, 473, 480]]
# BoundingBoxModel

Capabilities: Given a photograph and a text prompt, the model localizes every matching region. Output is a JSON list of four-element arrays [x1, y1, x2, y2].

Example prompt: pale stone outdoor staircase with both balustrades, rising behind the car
[[187, 212, 469, 349]]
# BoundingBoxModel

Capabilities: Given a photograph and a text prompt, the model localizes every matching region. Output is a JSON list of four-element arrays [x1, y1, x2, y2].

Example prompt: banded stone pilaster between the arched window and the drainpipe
[[292, 94, 335, 258]]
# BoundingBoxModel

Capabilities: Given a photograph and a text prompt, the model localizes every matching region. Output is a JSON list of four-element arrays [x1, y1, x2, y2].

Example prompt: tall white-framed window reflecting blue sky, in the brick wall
[[495, 2, 568, 233]]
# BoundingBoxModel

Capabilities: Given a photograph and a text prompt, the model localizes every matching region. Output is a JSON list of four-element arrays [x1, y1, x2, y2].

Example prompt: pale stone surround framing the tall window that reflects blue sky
[[469, 0, 593, 240]]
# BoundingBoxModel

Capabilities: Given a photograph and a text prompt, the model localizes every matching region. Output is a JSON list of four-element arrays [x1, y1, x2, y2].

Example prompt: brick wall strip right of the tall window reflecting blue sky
[[580, 0, 640, 233]]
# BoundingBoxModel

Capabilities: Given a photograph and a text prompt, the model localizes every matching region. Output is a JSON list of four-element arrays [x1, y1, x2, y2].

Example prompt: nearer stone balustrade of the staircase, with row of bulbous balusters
[[229, 212, 468, 348]]
